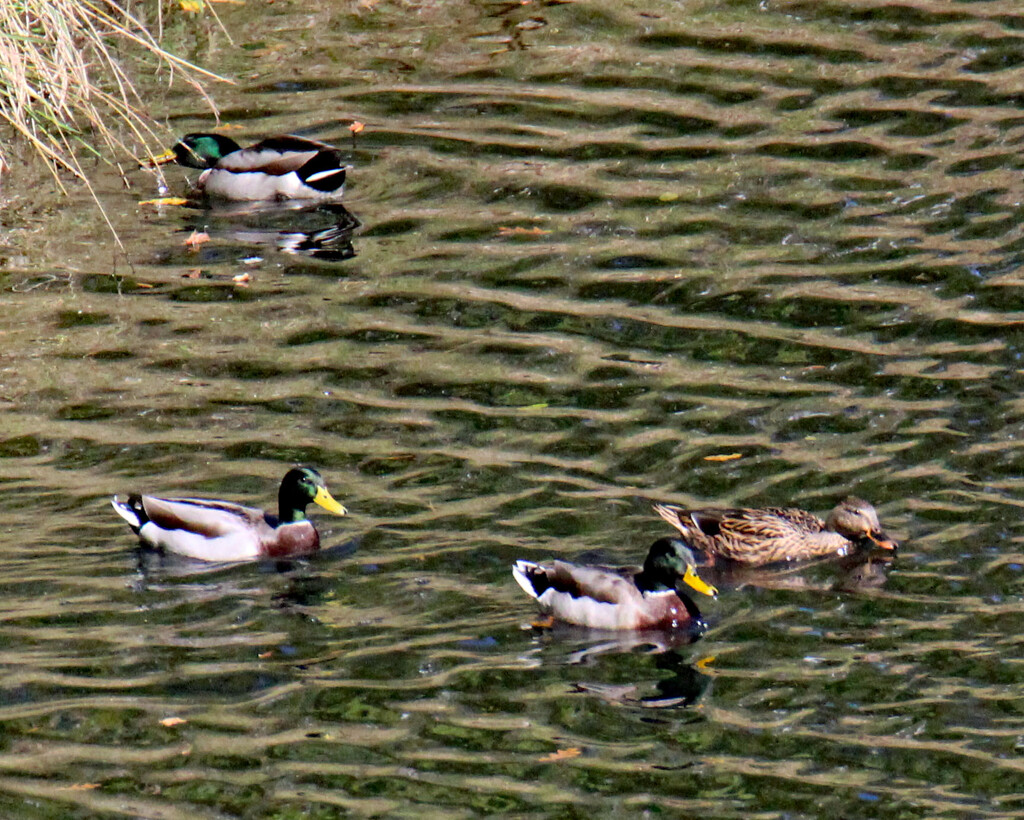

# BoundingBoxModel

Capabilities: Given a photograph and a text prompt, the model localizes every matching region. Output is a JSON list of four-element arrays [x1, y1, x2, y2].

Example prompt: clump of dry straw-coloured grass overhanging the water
[[0, 0, 220, 189]]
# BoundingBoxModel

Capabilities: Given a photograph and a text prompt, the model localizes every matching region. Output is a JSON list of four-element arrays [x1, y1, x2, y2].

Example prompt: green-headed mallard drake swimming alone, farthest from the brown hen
[[111, 467, 347, 561]]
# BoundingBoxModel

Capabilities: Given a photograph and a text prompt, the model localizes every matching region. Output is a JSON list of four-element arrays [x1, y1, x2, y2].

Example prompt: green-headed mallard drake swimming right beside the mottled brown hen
[[512, 538, 717, 630]]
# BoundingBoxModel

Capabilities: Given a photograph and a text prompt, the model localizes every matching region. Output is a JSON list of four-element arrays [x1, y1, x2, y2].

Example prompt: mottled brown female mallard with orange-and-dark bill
[[654, 497, 897, 566]]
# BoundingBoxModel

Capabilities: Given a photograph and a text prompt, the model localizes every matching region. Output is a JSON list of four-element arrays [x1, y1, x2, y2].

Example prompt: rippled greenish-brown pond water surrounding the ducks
[[0, 0, 1024, 818]]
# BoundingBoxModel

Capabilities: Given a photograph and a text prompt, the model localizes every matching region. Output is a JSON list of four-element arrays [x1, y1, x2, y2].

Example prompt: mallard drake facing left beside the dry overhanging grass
[[156, 134, 347, 202]]
